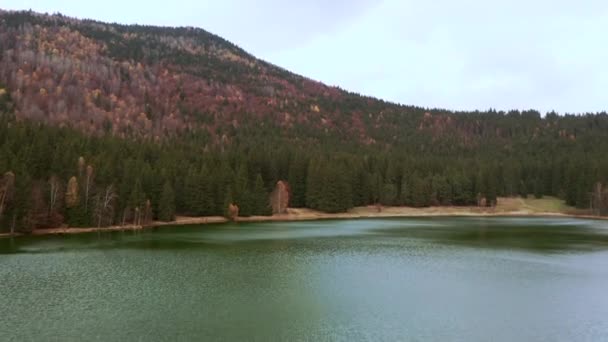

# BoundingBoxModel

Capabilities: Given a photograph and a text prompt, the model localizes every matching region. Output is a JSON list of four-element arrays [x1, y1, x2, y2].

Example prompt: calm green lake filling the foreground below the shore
[[0, 218, 608, 341]]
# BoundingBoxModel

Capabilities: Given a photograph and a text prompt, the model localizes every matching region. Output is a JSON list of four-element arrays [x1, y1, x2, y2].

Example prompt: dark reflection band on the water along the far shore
[[0, 217, 608, 254]]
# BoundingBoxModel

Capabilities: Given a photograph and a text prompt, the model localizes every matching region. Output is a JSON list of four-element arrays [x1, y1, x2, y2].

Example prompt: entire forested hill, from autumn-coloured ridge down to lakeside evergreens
[[0, 11, 608, 231]]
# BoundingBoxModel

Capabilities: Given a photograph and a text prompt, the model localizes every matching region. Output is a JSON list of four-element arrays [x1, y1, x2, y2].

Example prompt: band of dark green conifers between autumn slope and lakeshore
[[0, 108, 608, 232]]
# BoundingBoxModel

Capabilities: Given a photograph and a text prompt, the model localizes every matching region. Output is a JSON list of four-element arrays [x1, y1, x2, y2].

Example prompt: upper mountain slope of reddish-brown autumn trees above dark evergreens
[[0, 11, 608, 145]]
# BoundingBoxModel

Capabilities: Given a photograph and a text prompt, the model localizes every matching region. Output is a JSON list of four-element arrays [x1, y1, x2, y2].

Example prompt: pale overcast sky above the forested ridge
[[0, 0, 608, 113]]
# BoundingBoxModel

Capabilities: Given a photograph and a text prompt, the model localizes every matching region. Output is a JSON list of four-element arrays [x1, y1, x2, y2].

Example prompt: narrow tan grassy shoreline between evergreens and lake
[[0, 198, 608, 238]]
